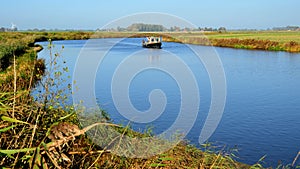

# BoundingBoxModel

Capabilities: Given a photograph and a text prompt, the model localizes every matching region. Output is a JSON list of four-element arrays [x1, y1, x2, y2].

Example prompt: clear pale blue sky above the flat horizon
[[0, 0, 300, 29]]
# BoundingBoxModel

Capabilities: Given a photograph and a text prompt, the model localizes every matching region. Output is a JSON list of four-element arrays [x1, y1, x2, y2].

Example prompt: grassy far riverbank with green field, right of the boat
[[166, 31, 300, 52]]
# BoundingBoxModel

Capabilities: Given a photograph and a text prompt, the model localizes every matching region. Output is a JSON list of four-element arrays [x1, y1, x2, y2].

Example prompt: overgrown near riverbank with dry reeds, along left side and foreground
[[0, 32, 298, 168]]
